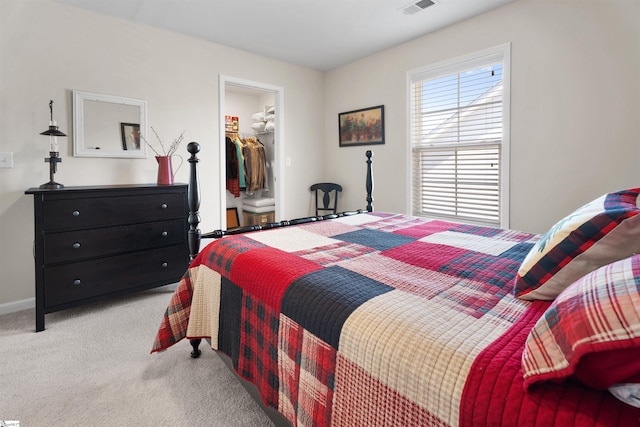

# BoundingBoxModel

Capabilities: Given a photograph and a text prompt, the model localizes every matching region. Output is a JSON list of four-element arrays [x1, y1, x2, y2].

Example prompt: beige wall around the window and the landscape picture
[[325, 0, 640, 232]]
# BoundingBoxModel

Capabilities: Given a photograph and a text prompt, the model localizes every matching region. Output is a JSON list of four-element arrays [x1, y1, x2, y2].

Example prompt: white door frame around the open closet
[[218, 74, 286, 230]]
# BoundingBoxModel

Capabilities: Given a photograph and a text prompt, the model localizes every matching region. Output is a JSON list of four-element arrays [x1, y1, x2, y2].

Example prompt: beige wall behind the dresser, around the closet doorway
[[0, 0, 324, 312]]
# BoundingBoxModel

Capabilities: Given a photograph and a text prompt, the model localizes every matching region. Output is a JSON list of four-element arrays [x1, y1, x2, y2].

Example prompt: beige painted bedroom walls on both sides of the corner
[[0, 0, 640, 312]]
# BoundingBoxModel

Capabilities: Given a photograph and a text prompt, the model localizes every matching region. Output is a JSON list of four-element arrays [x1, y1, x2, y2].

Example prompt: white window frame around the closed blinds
[[405, 43, 511, 228]]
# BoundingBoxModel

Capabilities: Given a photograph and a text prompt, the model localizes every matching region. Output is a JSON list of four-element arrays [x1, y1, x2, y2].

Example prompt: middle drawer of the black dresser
[[44, 219, 187, 264]]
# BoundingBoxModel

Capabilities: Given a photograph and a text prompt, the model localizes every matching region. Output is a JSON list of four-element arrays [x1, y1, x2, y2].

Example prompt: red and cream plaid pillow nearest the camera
[[522, 255, 640, 390]]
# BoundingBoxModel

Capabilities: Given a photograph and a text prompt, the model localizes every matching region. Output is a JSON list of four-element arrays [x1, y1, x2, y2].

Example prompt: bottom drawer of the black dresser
[[44, 245, 188, 308]]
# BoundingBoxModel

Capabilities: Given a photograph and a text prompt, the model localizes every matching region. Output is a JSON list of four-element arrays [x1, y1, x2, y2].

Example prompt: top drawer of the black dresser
[[43, 193, 185, 231]]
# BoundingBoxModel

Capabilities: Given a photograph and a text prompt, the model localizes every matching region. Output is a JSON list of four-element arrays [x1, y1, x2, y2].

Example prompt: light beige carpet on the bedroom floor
[[0, 287, 273, 427]]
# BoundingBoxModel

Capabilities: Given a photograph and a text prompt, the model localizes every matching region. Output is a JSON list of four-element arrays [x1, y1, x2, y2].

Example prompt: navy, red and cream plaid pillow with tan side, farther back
[[514, 188, 640, 300]]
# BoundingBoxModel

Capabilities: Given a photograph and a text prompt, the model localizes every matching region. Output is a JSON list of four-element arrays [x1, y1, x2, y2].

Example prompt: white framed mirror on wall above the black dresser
[[73, 90, 147, 158]]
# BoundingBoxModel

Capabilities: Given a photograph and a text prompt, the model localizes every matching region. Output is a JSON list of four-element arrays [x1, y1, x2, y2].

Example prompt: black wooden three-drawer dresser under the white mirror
[[25, 184, 189, 331]]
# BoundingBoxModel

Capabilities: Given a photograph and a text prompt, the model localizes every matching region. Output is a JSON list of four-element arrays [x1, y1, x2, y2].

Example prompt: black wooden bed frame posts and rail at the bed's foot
[[187, 142, 373, 358]]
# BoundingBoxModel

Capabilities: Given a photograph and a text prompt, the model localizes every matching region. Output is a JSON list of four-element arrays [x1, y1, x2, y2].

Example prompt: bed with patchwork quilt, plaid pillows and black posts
[[152, 146, 640, 426]]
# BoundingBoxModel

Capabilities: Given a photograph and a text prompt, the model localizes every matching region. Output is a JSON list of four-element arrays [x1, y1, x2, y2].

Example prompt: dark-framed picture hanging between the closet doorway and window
[[338, 105, 384, 147]]
